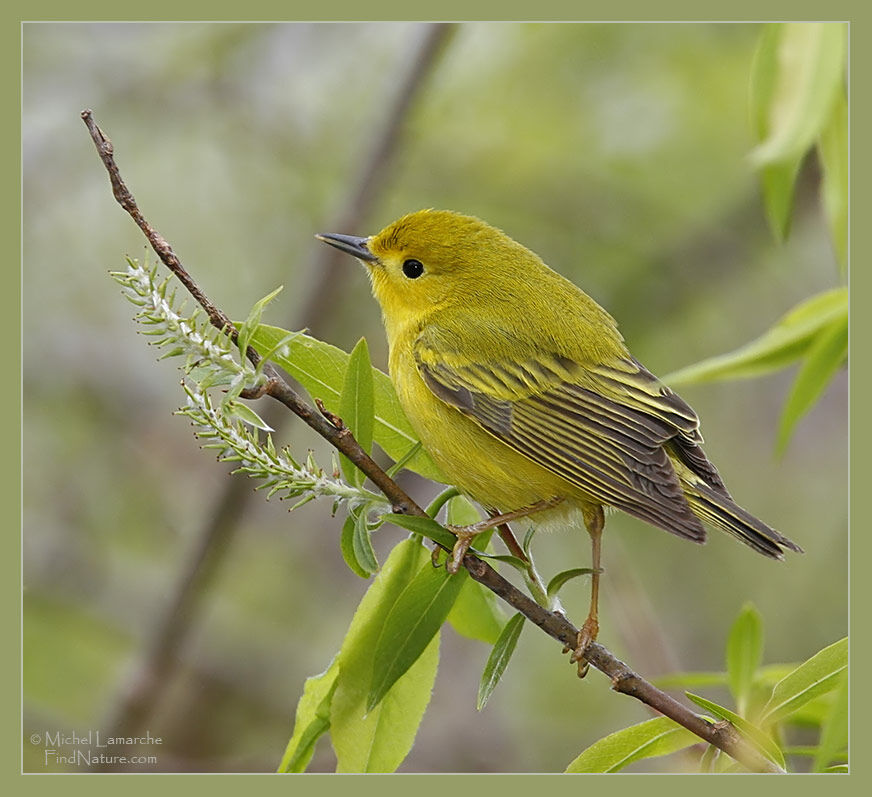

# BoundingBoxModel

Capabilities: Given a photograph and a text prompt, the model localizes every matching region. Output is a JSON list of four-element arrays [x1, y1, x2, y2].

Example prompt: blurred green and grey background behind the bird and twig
[[23, 23, 848, 772]]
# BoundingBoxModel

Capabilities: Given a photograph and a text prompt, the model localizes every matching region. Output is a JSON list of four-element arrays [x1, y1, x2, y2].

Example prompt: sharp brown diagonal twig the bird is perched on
[[82, 110, 782, 772]]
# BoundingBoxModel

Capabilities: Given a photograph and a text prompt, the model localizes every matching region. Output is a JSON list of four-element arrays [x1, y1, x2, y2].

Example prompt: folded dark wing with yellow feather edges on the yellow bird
[[415, 330, 725, 541]]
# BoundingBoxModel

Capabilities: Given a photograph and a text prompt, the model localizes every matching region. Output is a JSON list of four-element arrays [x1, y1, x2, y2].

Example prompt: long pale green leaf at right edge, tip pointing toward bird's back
[[663, 288, 848, 385]]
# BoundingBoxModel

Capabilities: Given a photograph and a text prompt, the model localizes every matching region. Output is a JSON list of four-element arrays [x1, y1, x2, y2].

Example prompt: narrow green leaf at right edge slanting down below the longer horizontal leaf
[[776, 311, 848, 454]]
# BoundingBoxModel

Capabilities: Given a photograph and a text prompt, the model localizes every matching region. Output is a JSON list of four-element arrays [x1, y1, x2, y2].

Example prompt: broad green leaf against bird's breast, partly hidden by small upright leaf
[[251, 324, 446, 482]]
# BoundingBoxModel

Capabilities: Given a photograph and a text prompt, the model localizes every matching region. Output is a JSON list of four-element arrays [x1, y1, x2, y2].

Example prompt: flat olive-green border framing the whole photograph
[[8, 6, 872, 795]]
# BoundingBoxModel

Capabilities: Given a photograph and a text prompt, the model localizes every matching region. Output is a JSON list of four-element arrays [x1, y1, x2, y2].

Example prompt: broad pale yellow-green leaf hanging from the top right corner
[[751, 22, 845, 166]]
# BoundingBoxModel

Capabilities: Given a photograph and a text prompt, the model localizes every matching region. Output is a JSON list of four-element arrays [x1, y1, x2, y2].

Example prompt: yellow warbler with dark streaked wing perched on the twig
[[318, 210, 801, 661]]
